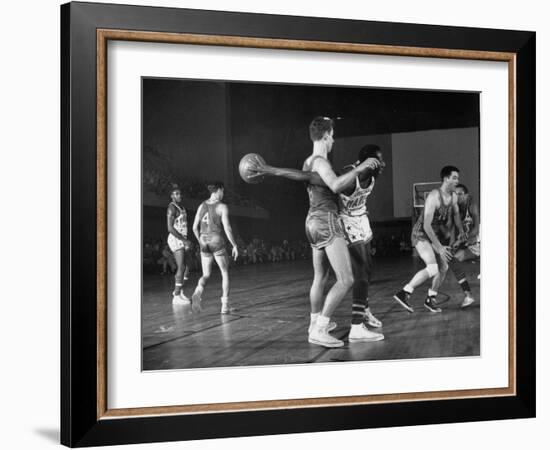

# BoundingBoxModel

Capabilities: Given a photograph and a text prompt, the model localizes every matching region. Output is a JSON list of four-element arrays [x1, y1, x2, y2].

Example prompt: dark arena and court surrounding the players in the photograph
[[142, 78, 480, 370]]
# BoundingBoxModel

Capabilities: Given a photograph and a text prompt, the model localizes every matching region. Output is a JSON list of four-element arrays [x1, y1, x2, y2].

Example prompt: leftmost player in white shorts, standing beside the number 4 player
[[166, 185, 192, 305]]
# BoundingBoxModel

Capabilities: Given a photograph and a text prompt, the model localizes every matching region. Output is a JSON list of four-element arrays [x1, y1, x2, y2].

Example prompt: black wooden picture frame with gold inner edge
[[61, 3, 535, 446]]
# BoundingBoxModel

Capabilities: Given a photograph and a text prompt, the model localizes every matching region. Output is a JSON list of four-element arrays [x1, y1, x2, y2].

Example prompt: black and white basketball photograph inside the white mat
[[141, 77, 483, 371]]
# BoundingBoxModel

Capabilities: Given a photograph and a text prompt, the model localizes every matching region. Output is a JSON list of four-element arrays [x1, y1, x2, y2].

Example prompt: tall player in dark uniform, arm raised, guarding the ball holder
[[251, 117, 384, 348]]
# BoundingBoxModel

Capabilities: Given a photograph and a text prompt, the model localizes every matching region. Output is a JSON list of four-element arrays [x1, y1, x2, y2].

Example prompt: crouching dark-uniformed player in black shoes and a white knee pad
[[393, 166, 464, 313]]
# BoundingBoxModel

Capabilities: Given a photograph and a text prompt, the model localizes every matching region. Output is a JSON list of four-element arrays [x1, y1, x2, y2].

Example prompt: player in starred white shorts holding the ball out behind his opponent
[[249, 144, 386, 342]]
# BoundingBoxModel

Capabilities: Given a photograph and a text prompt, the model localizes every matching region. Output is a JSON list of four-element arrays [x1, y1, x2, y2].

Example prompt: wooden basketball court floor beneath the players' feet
[[142, 255, 484, 370]]
